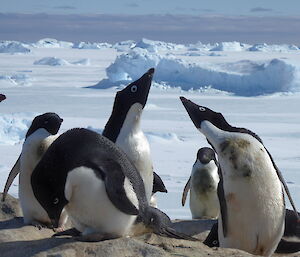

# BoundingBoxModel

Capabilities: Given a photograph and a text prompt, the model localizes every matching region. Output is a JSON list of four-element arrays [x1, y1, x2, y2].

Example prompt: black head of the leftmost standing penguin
[[25, 112, 63, 138]]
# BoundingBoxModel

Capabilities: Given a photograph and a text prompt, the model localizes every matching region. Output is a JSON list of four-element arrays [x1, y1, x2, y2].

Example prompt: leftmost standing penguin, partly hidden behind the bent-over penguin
[[2, 112, 66, 227]]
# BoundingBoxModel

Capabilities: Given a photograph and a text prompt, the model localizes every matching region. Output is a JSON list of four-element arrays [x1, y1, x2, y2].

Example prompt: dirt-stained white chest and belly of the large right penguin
[[218, 137, 285, 254]]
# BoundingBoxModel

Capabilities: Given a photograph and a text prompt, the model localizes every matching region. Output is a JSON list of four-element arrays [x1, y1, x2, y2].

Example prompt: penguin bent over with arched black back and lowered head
[[31, 128, 195, 241]]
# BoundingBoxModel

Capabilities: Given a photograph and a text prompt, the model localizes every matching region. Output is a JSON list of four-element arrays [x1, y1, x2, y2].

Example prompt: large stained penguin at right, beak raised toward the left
[[180, 97, 299, 256]]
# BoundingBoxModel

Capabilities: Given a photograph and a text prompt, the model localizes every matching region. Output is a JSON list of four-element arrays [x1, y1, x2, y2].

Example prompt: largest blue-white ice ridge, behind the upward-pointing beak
[[98, 48, 299, 96]]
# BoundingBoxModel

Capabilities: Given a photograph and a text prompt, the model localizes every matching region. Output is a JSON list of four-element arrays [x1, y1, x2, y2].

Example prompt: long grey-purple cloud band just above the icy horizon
[[0, 13, 300, 44]]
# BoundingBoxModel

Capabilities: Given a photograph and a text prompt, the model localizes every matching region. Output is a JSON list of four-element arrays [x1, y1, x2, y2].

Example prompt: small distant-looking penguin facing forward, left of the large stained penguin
[[182, 147, 220, 219]]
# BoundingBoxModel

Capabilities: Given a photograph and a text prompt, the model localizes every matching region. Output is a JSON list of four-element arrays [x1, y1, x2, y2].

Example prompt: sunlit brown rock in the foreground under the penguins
[[0, 195, 300, 257]]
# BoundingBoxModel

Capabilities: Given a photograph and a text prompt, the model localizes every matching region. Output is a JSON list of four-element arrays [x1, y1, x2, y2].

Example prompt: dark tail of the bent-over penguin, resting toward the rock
[[141, 206, 199, 241]]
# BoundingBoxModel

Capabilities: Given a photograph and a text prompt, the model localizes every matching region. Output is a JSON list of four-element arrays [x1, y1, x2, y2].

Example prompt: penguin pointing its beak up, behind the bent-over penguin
[[102, 68, 154, 202]]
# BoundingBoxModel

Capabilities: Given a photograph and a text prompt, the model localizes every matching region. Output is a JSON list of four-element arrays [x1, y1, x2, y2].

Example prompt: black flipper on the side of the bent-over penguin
[[99, 159, 139, 215]]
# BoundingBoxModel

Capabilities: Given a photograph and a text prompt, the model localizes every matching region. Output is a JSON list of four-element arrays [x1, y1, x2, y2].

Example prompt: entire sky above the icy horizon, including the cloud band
[[0, 0, 300, 45]]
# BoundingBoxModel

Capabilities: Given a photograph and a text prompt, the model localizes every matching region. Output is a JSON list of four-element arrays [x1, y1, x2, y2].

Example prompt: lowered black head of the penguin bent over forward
[[31, 164, 68, 228]]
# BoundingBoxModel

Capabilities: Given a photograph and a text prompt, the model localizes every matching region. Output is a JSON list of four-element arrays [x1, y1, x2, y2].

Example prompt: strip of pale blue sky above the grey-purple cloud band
[[0, 0, 300, 16]]
